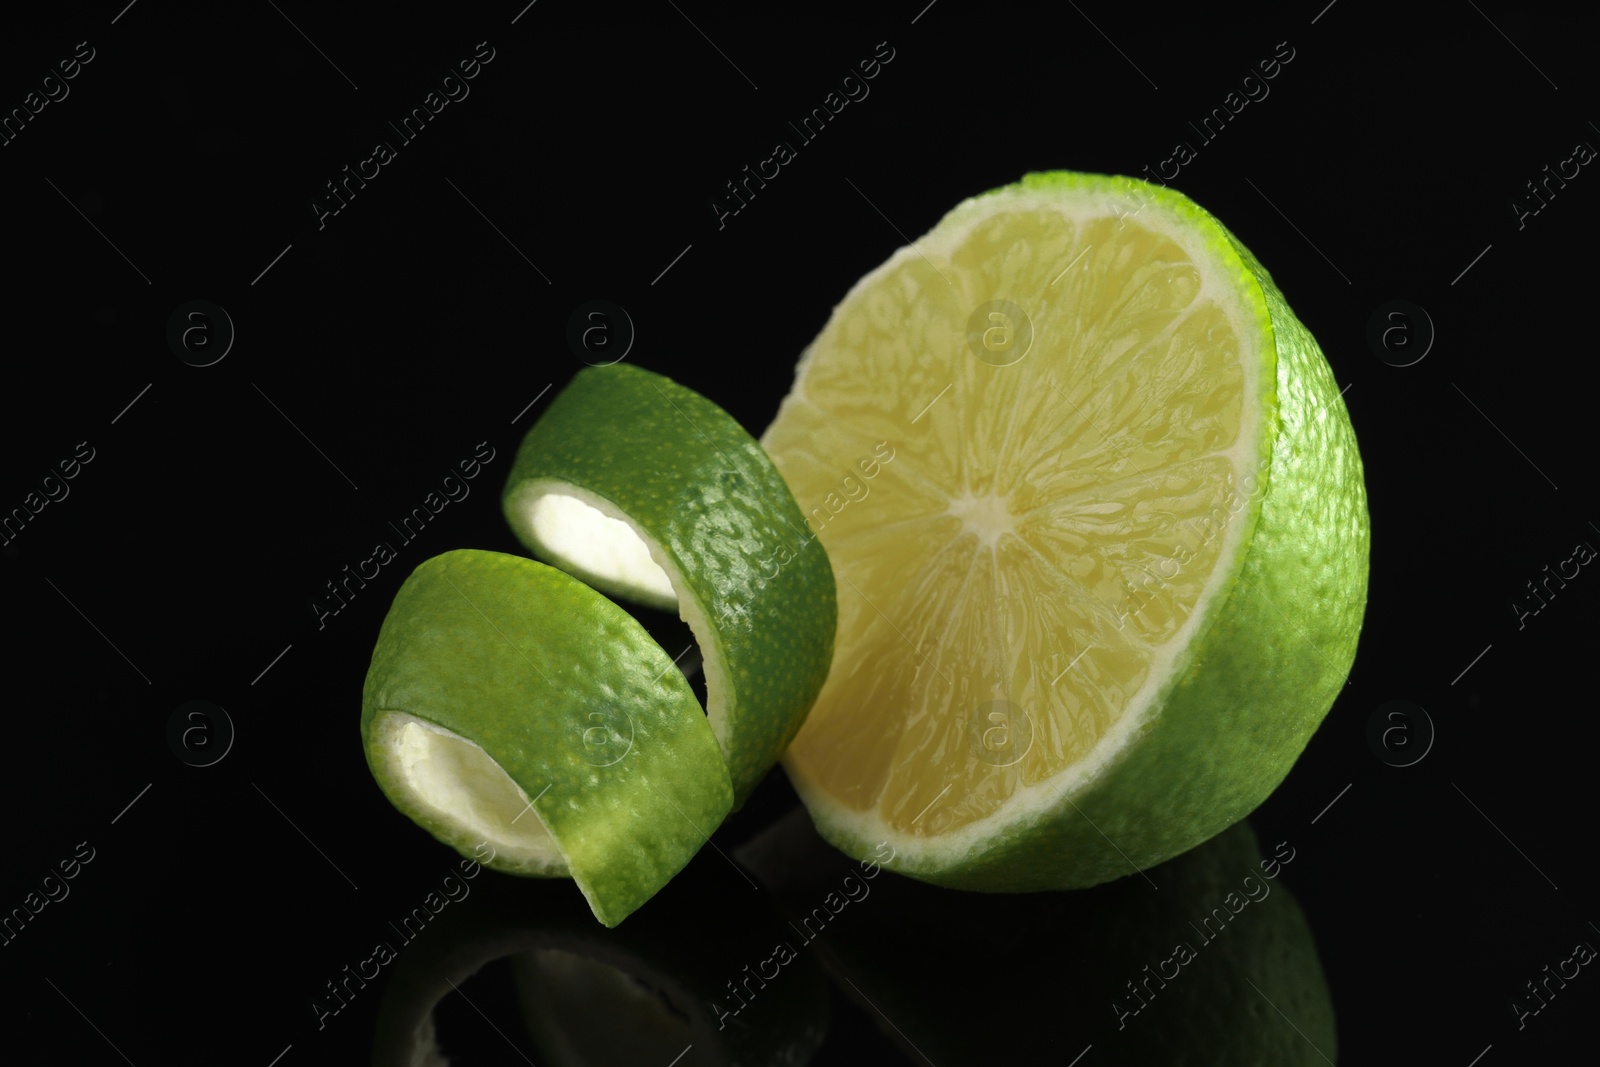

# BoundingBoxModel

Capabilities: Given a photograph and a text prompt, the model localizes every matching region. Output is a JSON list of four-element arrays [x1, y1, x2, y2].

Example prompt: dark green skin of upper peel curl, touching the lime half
[[501, 363, 837, 806]]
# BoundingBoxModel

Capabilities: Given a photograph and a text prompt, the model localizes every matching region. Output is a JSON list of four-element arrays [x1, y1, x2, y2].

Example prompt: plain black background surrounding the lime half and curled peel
[[0, 0, 1600, 1067]]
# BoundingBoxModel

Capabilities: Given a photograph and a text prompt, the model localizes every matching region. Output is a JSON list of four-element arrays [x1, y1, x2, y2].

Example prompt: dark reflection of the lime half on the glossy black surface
[[738, 811, 1338, 1067]]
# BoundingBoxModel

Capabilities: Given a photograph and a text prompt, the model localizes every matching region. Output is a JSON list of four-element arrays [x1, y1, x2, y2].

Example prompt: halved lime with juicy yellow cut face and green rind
[[762, 173, 1368, 889]]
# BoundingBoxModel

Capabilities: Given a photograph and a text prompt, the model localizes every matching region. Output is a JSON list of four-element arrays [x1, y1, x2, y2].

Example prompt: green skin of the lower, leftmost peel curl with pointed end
[[362, 550, 733, 926]]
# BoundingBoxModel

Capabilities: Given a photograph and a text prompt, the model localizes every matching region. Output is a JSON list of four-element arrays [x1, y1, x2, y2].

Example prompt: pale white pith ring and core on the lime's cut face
[[762, 177, 1269, 867]]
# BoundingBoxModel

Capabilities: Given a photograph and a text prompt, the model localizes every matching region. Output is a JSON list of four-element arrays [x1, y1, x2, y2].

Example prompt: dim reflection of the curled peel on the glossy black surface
[[373, 867, 829, 1067]]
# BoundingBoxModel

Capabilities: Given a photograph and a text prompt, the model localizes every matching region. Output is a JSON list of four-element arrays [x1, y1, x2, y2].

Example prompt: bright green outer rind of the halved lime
[[790, 173, 1371, 893]]
